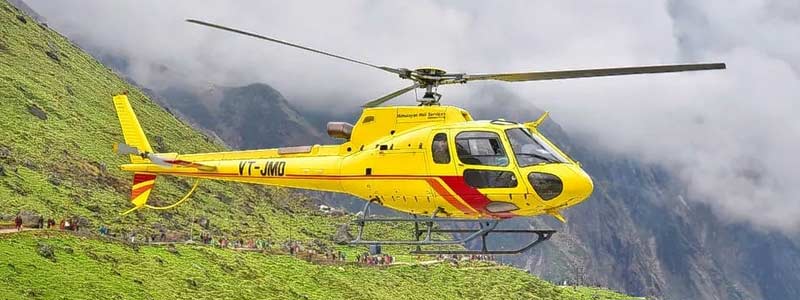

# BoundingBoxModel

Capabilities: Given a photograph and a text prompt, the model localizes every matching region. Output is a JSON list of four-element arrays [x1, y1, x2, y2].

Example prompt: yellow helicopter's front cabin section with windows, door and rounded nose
[[431, 121, 592, 213]]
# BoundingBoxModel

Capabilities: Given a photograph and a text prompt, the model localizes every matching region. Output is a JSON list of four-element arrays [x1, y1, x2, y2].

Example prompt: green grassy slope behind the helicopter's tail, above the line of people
[[0, 2, 343, 239]]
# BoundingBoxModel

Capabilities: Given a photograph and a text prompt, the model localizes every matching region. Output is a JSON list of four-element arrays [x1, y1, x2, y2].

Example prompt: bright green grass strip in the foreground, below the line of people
[[0, 231, 630, 299]]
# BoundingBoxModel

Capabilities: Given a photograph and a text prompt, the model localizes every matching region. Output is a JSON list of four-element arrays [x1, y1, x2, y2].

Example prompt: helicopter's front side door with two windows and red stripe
[[453, 130, 527, 213]]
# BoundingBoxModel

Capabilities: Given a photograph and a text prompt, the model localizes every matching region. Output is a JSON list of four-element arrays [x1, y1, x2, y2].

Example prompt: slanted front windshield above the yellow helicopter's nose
[[506, 128, 566, 167]]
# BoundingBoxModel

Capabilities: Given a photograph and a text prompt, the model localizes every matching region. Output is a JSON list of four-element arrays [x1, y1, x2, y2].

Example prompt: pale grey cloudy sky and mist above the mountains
[[27, 0, 800, 233]]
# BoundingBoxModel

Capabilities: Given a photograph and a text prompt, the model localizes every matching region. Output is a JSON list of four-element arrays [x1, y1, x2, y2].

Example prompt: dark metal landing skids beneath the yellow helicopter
[[348, 201, 556, 255]]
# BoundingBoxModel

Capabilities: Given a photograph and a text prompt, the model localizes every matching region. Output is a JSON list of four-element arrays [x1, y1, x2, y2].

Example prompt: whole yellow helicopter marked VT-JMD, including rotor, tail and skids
[[113, 19, 726, 254]]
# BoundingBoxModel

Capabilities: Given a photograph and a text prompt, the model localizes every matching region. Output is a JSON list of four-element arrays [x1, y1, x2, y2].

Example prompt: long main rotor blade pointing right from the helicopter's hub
[[464, 63, 725, 81]]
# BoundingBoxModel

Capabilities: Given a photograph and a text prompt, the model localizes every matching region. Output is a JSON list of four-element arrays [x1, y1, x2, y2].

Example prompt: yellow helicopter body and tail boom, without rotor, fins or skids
[[122, 106, 593, 219]]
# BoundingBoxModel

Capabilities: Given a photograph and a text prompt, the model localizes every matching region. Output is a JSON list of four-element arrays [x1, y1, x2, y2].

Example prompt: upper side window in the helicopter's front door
[[456, 131, 508, 167]]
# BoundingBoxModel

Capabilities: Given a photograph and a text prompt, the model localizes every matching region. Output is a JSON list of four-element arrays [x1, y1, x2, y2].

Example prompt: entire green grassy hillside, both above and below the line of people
[[0, 0, 636, 299]]
